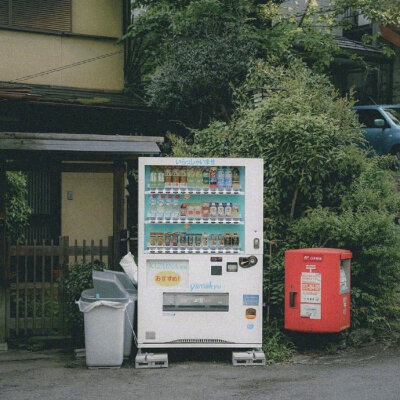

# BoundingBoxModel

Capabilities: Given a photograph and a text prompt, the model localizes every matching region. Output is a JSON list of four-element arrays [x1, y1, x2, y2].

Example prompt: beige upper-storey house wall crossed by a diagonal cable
[[0, 0, 124, 91]]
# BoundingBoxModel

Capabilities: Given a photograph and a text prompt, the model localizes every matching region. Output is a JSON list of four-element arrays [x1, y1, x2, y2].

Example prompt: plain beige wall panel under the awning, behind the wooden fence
[[61, 172, 113, 245]]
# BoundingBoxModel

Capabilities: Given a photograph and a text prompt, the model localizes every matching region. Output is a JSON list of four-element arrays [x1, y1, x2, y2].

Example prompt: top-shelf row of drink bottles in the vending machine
[[149, 165, 240, 190]]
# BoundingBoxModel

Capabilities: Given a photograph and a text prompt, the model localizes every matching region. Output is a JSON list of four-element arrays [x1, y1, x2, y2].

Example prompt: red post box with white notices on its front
[[285, 248, 352, 333]]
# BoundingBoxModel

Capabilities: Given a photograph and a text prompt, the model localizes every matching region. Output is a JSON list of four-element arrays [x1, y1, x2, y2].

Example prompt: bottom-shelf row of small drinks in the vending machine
[[150, 232, 240, 249]]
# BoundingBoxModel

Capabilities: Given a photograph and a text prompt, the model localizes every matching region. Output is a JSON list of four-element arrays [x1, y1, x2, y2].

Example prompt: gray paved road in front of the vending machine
[[0, 345, 400, 400]]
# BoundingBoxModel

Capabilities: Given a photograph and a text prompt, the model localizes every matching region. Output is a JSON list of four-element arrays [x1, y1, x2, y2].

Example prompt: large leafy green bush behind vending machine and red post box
[[171, 60, 400, 356]]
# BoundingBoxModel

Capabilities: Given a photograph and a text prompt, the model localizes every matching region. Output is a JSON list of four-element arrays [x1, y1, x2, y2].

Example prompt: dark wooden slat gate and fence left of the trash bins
[[5, 237, 113, 338]]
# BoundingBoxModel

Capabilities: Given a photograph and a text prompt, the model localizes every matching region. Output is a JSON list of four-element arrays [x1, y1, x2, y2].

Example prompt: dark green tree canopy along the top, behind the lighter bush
[[125, 0, 400, 128]]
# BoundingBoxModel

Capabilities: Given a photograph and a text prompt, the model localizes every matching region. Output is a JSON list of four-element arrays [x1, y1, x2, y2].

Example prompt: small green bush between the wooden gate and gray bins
[[61, 262, 105, 347]]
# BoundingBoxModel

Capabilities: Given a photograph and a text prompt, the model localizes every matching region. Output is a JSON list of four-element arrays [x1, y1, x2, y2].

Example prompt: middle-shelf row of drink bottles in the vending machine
[[147, 194, 241, 219]]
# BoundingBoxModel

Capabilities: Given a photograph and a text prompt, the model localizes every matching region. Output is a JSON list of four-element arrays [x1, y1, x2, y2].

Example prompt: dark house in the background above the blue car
[[283, 0, 400, 104]]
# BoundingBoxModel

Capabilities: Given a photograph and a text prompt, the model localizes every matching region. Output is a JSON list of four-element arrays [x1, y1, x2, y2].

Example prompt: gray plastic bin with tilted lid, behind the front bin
[[93, 270, 137, 357]]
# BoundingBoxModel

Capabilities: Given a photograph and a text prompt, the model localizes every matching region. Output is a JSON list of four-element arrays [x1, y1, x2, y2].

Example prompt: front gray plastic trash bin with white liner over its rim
[[78, 289, 130, 367]]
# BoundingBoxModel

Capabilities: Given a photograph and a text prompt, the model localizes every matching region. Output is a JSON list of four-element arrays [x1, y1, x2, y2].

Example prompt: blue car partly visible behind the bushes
[[353, 104, 400, 161]]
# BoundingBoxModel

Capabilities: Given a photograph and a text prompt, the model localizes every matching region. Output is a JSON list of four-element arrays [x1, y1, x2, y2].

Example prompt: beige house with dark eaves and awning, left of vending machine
[[0, 0, 163, 343]]
